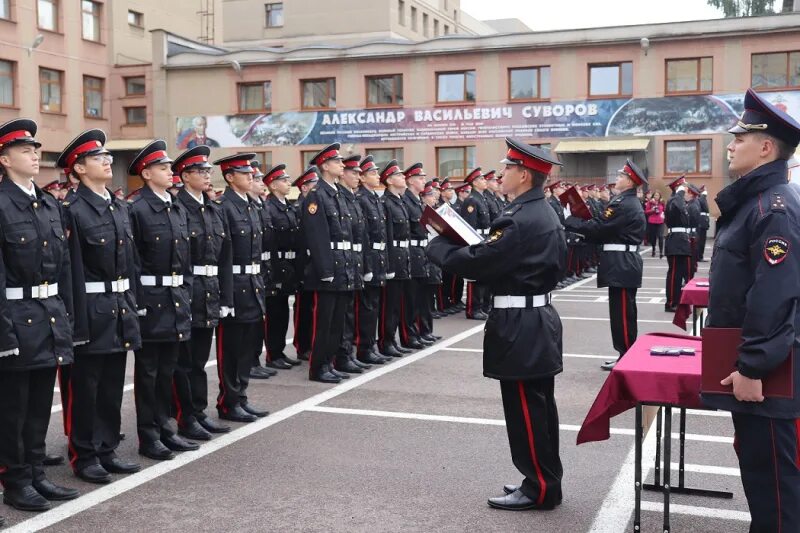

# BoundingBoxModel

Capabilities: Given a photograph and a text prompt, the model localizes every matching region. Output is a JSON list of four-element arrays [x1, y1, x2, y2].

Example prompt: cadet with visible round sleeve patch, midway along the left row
[[300, 143, 356, 383]]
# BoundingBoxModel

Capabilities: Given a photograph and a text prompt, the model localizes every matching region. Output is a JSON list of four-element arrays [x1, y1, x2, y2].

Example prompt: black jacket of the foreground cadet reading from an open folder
[[427, 189, 566, 380]]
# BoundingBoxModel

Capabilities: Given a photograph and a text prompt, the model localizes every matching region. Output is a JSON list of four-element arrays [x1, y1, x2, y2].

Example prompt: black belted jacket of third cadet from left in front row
[[129, 185, 192, 342]]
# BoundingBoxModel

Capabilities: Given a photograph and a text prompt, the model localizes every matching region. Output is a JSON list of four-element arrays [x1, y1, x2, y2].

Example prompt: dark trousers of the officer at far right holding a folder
[[732, 413, 800, 533]]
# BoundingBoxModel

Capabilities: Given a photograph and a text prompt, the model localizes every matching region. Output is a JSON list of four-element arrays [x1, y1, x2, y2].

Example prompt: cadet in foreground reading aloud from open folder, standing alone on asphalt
[[427, 139, 566, 510]]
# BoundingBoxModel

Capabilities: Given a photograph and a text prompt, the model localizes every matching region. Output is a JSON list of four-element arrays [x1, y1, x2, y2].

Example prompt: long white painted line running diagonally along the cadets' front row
[[10, 324, 483, 533]]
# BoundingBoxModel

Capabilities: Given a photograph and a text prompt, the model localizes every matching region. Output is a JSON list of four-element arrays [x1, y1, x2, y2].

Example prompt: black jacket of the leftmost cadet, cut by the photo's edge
[[0, 178, 75, 371]]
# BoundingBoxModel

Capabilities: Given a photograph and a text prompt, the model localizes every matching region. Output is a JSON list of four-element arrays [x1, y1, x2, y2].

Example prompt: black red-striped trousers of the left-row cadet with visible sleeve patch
[[308, 291, 346, 378]]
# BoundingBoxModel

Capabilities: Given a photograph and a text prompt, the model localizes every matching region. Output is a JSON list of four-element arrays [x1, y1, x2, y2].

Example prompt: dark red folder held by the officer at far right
[[700, 328, 794, 398]]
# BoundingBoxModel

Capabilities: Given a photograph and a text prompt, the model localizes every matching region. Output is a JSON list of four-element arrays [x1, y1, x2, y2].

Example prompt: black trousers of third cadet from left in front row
[[133, 342, 181, 445]]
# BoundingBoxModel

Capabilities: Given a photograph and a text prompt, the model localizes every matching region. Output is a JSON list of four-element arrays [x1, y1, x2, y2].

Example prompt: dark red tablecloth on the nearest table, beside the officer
[[578, 333, 702, 444]]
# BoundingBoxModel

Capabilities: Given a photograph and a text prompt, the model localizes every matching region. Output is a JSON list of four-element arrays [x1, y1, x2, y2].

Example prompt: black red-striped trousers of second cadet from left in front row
[[67, 352, 128, 471]]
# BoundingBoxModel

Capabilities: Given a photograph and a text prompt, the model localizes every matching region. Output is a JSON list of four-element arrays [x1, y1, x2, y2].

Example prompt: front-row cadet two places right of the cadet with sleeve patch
[[354, 155, 391, 365]]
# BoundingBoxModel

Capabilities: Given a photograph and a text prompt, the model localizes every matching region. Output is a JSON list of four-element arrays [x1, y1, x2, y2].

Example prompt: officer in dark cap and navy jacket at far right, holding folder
[[704, 89, 800, 533]]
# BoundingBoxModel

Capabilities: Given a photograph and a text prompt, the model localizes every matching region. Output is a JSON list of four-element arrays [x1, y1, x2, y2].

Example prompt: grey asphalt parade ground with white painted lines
[[0, 242, 749, 533]]
